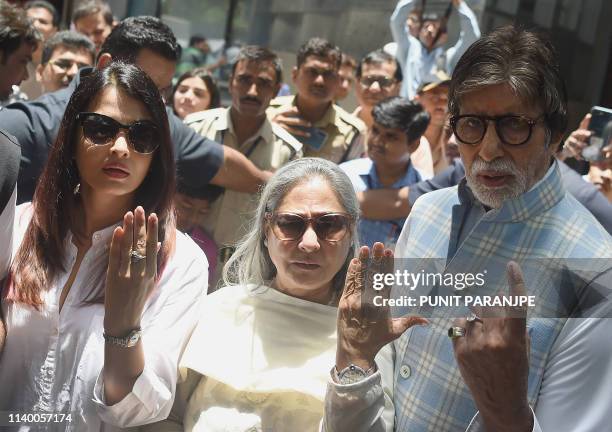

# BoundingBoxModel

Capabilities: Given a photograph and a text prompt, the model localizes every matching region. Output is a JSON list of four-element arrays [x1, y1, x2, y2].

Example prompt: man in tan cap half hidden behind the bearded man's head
[[415, 72, 450, 175]]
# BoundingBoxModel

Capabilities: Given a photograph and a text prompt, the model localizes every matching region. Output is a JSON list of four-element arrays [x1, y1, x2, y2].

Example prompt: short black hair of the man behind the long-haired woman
[[99, 15, 181, 63]]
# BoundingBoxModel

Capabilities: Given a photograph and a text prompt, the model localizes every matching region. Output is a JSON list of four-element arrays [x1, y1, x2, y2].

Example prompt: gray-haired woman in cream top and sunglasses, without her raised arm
[[142, 158, 393, 432]]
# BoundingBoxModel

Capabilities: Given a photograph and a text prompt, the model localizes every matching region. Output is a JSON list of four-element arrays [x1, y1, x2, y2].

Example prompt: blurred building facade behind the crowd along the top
[[8, 0, 612, 131]]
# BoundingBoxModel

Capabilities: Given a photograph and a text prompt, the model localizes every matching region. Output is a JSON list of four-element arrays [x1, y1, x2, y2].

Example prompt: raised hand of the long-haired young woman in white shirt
[[104, 206, 159, 337]]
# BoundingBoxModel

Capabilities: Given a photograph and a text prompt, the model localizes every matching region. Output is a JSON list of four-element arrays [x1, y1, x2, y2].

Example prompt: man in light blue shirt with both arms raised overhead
[[390, 0, 480, 99]]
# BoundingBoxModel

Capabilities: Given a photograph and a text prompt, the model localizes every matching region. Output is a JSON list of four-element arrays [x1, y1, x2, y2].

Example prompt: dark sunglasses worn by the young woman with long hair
[[76, 112, 161, 154]]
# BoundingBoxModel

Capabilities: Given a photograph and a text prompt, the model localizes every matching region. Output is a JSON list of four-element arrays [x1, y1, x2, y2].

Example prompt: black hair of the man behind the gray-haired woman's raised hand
[[372, 96, 429, 143]]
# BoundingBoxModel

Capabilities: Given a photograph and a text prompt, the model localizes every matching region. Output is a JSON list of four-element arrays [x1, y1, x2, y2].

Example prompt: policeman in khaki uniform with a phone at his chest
[[268, 38, 366, 163]]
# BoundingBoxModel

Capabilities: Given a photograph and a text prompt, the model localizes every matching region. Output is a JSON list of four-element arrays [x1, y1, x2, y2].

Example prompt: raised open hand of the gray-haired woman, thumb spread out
[[336, 243, 427, 370]]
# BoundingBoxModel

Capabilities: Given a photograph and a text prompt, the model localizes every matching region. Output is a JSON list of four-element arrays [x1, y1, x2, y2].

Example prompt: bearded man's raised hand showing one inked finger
[[453, 261, 533, 432]]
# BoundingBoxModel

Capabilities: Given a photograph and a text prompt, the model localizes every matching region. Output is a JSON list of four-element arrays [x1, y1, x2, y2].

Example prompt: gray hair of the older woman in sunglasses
[[223, 158, 359, 298]]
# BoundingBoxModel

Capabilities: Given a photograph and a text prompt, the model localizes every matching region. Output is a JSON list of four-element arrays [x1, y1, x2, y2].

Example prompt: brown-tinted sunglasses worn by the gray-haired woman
[[266, 213, 352, 242]]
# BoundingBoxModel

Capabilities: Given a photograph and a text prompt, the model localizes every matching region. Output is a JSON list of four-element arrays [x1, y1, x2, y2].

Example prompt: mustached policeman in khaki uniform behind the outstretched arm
[[185, 46, 303, 286]]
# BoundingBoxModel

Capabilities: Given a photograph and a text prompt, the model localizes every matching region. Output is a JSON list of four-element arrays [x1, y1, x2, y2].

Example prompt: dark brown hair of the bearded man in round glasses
[[448, 25, 567, 136]]
